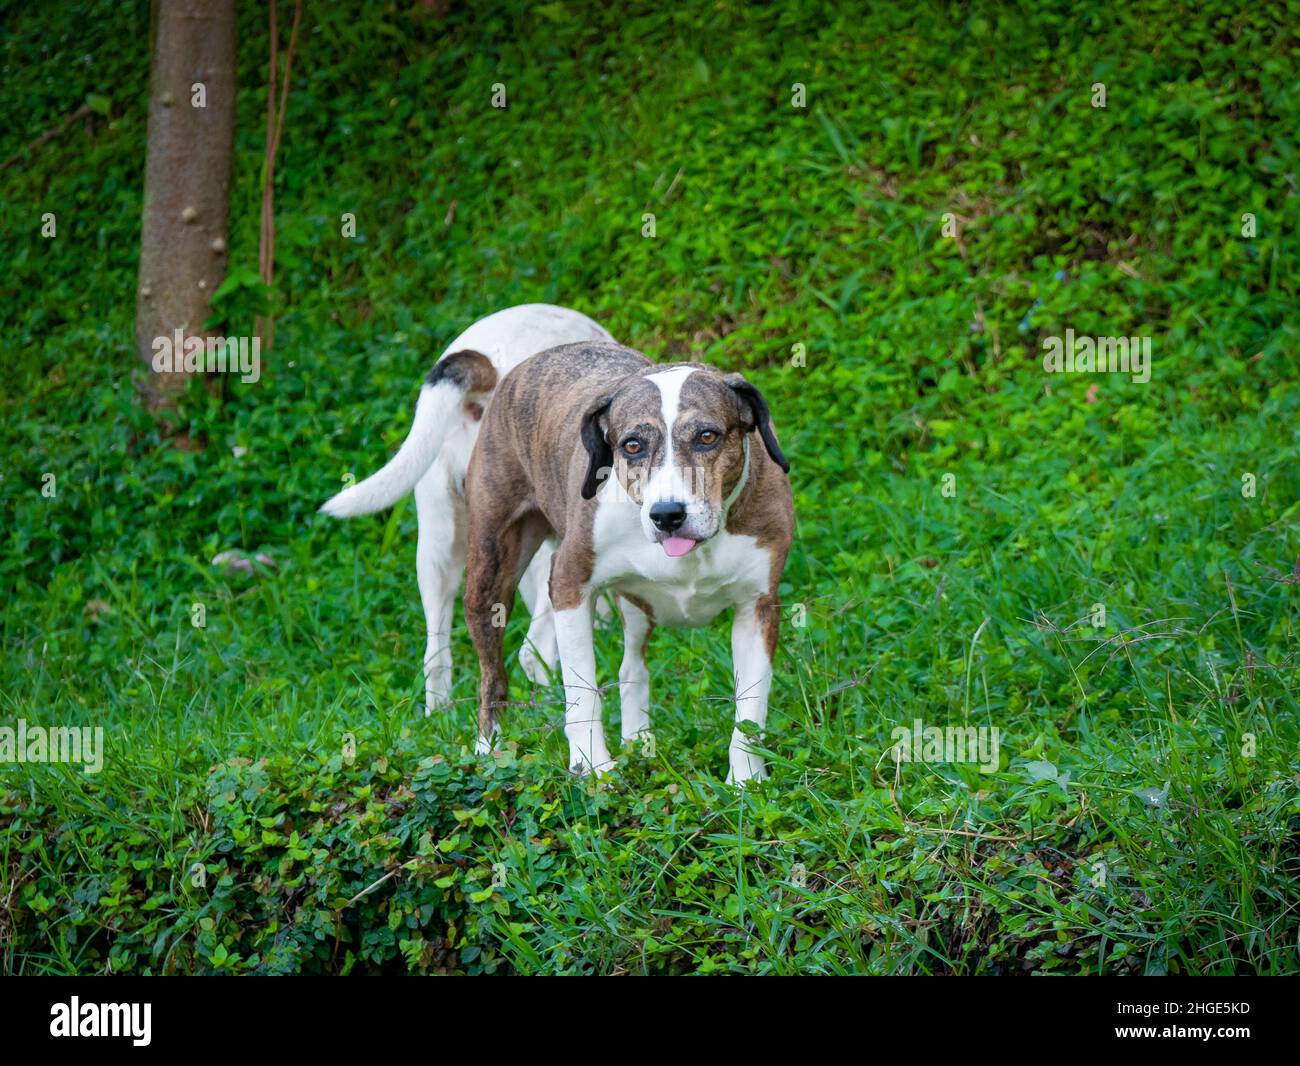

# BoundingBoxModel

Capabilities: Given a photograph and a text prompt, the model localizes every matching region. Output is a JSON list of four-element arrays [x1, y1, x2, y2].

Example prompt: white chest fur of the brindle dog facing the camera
[[592, 493, 772, 625]]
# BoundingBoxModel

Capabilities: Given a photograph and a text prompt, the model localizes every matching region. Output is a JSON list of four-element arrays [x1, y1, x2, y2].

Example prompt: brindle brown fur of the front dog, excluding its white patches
[[464, 342, 794, 737]]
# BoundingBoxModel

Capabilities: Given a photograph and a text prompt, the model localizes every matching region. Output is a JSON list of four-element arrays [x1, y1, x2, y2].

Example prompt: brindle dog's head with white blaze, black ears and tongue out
[[581, 364, 790, 556]]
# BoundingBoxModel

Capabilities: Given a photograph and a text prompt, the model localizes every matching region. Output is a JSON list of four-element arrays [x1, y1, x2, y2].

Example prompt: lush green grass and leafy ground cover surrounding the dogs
[[0, 0, 1300, 974]]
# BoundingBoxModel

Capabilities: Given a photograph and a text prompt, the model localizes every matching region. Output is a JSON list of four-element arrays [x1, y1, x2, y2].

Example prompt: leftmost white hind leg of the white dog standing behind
[[415, 463, 465, 715]]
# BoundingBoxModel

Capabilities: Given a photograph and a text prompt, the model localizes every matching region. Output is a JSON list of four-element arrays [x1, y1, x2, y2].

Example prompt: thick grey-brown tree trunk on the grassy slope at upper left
[[135, 0, 235, 411]]
